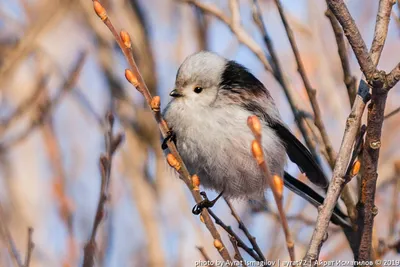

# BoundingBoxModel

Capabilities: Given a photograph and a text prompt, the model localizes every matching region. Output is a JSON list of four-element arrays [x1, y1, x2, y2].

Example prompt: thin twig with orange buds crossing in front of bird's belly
[[247, 116, 296, 261]]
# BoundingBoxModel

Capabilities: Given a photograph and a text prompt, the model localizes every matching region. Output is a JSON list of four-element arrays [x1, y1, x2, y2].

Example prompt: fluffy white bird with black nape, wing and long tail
[[162, 51, 349, 227]]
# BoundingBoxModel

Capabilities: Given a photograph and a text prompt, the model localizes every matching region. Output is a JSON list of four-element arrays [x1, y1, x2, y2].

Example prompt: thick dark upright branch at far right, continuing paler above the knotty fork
[[355, 0, 395, 261]]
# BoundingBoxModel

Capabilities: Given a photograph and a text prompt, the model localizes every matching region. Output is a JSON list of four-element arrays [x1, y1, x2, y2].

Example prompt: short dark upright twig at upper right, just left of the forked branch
[[325, 9, 357, 107]]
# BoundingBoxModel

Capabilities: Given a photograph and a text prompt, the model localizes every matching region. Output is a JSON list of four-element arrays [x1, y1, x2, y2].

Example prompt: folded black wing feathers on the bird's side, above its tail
[[270, 122, 329, 188]]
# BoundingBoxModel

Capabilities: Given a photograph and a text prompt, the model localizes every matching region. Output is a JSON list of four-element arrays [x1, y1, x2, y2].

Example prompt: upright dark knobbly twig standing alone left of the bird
[[82, 113, 123, 267]]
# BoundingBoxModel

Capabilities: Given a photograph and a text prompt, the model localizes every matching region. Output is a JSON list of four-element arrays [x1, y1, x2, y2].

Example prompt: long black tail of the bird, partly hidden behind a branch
[[283, 172, 351, 228]]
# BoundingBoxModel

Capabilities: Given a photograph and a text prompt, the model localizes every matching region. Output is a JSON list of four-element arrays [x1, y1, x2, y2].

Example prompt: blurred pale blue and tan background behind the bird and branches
[[0, 0, 400, 267]]
